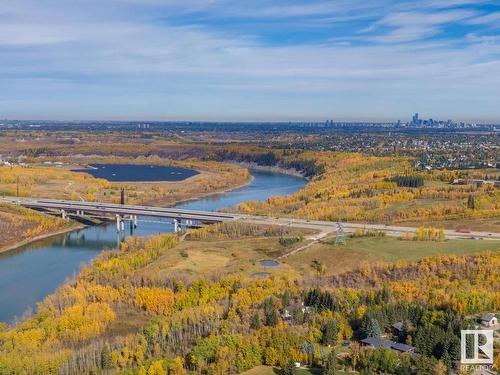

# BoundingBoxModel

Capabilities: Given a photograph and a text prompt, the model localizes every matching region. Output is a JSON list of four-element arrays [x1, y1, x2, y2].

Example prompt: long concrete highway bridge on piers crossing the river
[[0, 197, 236, 231]]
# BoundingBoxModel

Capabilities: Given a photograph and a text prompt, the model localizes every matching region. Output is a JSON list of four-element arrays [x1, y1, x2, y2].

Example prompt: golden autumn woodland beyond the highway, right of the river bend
[[232, 151, 500, 222]]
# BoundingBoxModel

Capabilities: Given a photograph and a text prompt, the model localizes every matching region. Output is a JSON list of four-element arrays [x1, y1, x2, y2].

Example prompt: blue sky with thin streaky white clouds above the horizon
[[0, 0, 500, 122]]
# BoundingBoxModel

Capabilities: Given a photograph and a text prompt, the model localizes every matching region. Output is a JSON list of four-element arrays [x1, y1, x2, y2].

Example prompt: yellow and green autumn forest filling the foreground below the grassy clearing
[[0, 225, 500, 375]]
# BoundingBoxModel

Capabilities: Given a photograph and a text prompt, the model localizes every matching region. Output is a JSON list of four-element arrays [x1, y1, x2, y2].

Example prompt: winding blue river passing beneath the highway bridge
[[0, 170, 306, 322]]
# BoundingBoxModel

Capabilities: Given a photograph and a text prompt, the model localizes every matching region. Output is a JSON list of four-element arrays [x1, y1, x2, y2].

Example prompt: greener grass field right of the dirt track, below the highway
[[285, 237, 500, 276]]
